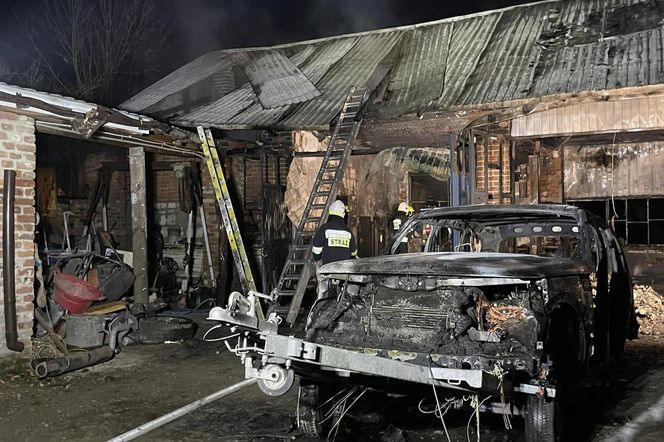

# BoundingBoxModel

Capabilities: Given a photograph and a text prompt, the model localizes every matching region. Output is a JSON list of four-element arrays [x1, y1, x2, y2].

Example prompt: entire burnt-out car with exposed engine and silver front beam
[[211, 205, 636, 440]]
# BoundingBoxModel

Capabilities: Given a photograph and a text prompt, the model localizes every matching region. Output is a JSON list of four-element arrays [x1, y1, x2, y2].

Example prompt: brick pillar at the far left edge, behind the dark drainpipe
[[0, 112, 36, 355]]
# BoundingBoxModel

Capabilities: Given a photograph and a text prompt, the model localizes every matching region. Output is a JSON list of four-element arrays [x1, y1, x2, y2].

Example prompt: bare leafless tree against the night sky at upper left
[[14, 0, 168, 104]]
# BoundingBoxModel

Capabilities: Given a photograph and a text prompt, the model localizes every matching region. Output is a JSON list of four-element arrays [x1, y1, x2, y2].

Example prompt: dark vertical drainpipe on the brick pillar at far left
[[2, 170, 24, 352]]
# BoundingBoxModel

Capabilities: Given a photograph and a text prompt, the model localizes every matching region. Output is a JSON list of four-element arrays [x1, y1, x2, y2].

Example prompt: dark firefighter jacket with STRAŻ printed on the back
[[311, 215, 357, 264]]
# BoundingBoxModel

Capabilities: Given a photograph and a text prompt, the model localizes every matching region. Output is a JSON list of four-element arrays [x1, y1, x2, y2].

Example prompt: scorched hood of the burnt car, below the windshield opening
[[320, 252, 589, 279]]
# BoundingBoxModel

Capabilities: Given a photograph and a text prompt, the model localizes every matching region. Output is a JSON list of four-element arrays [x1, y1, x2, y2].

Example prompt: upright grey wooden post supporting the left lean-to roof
[[129, 147, 148, 306]]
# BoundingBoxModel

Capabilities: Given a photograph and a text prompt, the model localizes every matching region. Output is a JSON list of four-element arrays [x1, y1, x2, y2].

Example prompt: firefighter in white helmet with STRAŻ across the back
[[311, 200, 357, 299]]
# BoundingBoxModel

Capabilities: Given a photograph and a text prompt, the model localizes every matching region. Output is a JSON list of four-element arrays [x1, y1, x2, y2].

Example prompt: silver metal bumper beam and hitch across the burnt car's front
[[208, 292, 556, 415]]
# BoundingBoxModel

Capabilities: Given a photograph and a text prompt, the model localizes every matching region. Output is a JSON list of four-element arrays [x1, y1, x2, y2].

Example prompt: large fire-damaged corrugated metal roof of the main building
[[122, 0, 664, 129]]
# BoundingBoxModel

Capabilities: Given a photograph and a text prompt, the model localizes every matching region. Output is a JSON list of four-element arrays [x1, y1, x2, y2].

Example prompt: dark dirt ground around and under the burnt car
[[0, 312, 664, 441]]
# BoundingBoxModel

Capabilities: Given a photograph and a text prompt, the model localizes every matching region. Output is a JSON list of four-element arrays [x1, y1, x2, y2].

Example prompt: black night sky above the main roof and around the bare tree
[[0, 0, 530, 98]]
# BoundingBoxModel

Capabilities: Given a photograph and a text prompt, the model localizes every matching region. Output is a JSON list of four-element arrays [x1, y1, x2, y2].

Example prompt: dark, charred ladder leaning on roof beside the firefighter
[[273, 87, 368, 325]]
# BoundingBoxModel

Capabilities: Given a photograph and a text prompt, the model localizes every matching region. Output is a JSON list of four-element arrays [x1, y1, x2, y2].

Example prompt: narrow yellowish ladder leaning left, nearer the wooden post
[[197, 126, 264, 319]]
